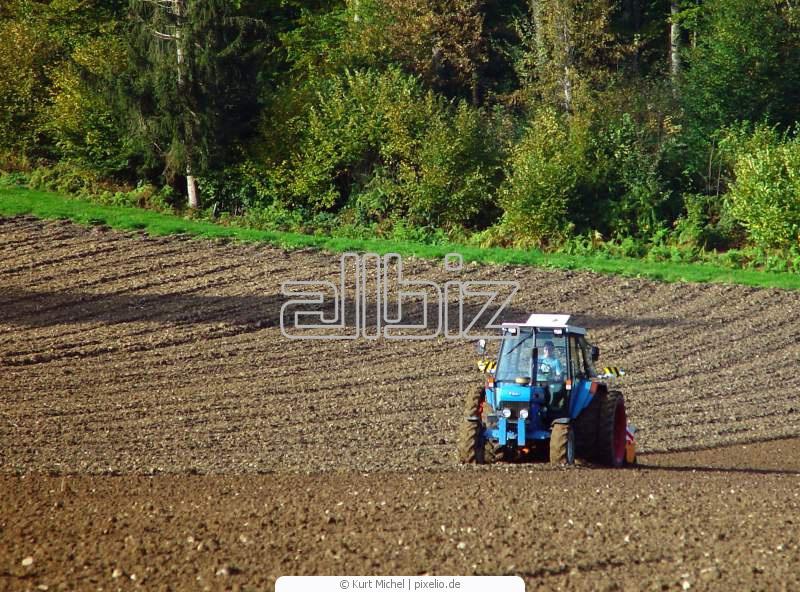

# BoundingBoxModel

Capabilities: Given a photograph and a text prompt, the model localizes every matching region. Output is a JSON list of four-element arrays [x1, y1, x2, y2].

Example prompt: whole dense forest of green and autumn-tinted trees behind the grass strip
[[0, 0, 800, 273]]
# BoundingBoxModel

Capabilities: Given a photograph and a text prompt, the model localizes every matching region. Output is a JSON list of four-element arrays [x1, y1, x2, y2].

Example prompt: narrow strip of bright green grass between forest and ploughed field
[[0, 187, 800, 290]]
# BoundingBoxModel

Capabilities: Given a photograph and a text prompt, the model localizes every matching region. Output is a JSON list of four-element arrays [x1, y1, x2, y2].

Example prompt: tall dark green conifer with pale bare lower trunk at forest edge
[[125, 0, 263, 208]]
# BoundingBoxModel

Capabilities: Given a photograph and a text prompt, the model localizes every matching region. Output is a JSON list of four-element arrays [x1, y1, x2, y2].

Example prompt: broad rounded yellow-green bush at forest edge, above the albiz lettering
[[281, 68, 499, 227]]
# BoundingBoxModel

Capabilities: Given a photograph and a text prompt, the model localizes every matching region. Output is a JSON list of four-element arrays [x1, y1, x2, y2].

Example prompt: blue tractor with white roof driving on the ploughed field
[[458, 314, 636, 467]]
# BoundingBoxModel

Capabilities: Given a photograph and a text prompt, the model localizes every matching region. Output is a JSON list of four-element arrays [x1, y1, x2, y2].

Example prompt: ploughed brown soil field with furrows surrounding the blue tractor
[[0, 218, 800, 590]]
